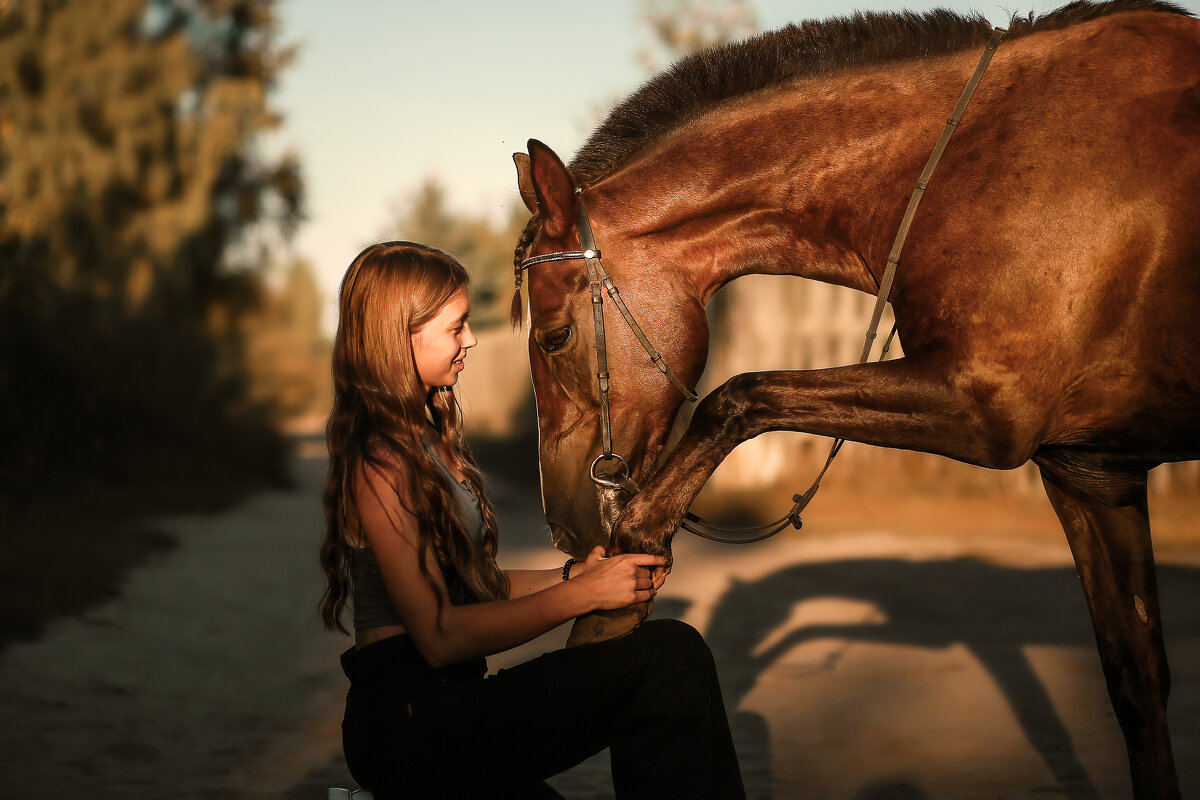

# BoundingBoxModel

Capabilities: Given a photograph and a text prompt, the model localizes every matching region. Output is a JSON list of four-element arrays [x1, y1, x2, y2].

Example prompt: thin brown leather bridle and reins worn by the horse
[[521, 28, 1008, 545]]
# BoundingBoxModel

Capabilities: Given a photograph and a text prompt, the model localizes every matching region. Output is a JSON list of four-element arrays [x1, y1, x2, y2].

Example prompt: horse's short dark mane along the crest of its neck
[[570, 0, 1188, 186]]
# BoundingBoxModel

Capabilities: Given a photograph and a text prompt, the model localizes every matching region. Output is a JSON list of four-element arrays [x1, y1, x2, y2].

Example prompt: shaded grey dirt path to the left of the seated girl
[[0, 450, 341, 800]]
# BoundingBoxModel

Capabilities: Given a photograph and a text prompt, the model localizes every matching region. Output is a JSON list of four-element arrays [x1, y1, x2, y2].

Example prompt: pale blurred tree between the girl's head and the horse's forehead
[[383, 179, 529, 329]]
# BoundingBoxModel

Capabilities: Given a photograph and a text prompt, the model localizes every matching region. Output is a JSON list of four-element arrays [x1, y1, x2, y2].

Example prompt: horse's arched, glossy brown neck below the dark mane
[[596, 66, 953, 302]]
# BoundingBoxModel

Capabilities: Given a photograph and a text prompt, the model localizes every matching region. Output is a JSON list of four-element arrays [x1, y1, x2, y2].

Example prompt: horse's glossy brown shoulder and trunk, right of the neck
[[906, 12, 1200, 461]]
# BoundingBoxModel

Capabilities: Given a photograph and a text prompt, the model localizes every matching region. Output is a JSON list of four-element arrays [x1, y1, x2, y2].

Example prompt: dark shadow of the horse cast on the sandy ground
[[691, 558, 1200, 800]]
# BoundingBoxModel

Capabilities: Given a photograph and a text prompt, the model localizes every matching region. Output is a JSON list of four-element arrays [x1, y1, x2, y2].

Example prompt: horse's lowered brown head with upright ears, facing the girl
[[514, 140, 708, 557]]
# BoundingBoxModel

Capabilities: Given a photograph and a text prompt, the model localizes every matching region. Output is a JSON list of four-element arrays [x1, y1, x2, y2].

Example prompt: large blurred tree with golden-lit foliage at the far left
[[0, 0, 302, 510]]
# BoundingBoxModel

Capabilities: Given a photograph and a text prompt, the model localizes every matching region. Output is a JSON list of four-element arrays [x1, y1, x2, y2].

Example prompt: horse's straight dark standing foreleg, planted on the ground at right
[[1034, 449, 1180, 800]]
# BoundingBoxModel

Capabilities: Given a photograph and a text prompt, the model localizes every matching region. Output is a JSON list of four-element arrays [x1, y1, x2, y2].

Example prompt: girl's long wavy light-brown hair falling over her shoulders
[[320, 241, 509, 633]]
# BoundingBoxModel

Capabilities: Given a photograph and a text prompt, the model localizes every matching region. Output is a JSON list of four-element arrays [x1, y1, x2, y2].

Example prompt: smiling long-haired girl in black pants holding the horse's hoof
[[320, 242, 744, 800]]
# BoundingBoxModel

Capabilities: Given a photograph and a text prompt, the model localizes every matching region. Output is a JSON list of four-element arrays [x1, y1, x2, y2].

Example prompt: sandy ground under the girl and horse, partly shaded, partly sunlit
[[0, 443, 1200, 800]]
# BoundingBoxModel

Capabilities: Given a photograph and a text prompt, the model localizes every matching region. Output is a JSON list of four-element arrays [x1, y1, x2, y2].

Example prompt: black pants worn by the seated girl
[[342, 620, 745, 800]]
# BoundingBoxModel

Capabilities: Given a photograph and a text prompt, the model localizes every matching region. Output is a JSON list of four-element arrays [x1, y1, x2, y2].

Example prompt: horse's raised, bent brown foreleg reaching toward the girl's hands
[[613, 357, 1039, 552]]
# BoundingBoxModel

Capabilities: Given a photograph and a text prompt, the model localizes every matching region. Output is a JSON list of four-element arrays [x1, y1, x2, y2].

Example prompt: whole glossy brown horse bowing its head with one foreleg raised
[[516, 0, 1200, 798]]
